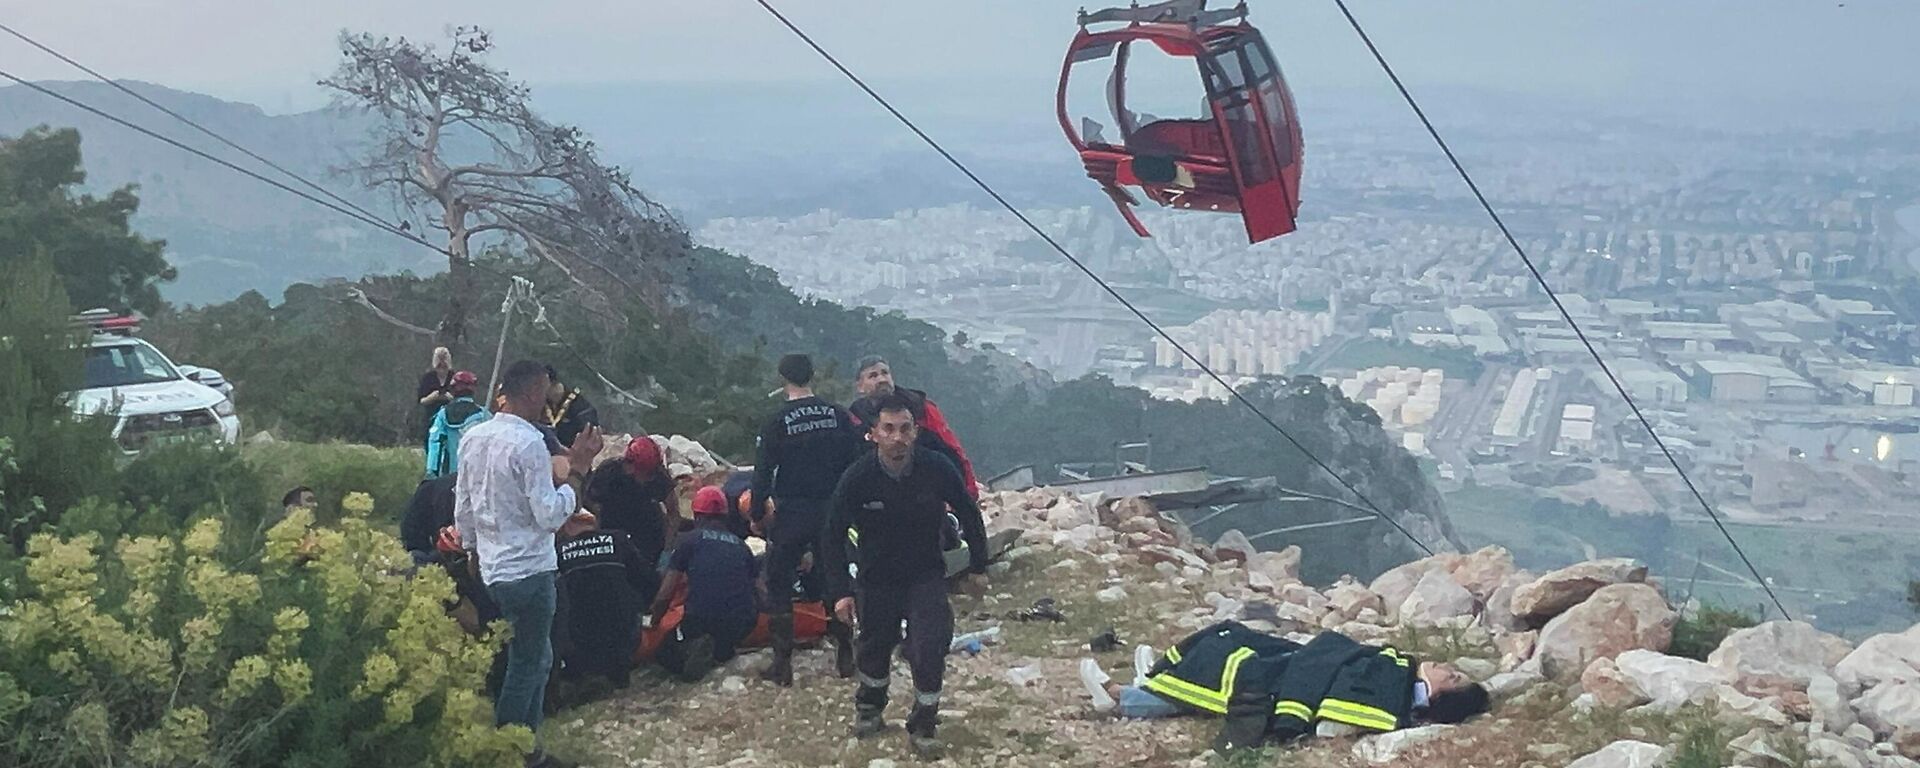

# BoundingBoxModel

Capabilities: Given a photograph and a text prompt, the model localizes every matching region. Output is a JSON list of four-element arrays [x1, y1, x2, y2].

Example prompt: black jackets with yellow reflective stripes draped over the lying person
[[1146, 620, 1419, 741]]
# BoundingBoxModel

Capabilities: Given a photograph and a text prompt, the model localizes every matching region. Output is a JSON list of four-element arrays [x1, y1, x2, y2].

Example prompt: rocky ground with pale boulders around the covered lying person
[[549, 490, 1920, 768]]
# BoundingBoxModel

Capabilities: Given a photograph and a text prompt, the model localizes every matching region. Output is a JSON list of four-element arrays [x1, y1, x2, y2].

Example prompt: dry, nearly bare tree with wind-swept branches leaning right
[[321, 27, 689, 344]]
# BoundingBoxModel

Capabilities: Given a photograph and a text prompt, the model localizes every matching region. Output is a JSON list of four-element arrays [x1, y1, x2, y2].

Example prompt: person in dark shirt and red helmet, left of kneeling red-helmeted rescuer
[[586, 434, 678, 599]]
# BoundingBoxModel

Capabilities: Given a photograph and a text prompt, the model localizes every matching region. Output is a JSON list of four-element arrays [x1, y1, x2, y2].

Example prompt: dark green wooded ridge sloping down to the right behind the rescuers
[[150, 242, 1457, 580]]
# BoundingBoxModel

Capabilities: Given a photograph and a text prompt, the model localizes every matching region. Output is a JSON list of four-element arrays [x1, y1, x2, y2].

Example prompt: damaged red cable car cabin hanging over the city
[[1058, 0, 1300, 242]]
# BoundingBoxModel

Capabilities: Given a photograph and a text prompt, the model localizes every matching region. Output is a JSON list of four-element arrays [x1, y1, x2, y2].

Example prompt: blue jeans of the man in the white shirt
[[486, 570, 555, 743]]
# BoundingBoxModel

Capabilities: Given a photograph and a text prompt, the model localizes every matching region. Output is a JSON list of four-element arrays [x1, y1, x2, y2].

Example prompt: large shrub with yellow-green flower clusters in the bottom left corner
[[0, 495, 532, 766]]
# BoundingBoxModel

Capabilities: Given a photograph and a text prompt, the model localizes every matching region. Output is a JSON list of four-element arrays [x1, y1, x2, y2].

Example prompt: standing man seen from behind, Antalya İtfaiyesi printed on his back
[[747, 355, 860, 687]]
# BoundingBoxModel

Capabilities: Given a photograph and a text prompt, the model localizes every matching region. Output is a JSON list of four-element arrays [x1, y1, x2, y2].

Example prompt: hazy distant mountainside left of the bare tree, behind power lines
[[0, 81, 428, 303]]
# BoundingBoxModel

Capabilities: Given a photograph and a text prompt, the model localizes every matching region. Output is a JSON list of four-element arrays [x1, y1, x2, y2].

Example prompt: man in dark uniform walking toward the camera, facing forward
[[820, 394, 987, 753]]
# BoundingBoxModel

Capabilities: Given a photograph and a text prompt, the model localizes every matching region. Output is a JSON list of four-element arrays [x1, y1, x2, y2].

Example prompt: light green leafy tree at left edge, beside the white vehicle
[[0, 255, 113, 555]]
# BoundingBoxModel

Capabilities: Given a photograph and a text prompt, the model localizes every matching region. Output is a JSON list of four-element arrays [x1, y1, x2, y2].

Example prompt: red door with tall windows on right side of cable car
[[1206, 31, 1300, 242]]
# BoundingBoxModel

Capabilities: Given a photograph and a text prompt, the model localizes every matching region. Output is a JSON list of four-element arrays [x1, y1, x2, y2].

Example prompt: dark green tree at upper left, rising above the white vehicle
[[0, 127, 175, 313]]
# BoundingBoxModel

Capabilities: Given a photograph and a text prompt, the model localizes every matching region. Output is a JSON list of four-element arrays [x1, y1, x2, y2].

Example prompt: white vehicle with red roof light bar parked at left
[[69, 309, 240, 455]]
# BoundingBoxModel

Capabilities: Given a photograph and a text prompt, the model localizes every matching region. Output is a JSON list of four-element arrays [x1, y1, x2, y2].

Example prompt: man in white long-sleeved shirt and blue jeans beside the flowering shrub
[[453, 361, 601, 766]]
